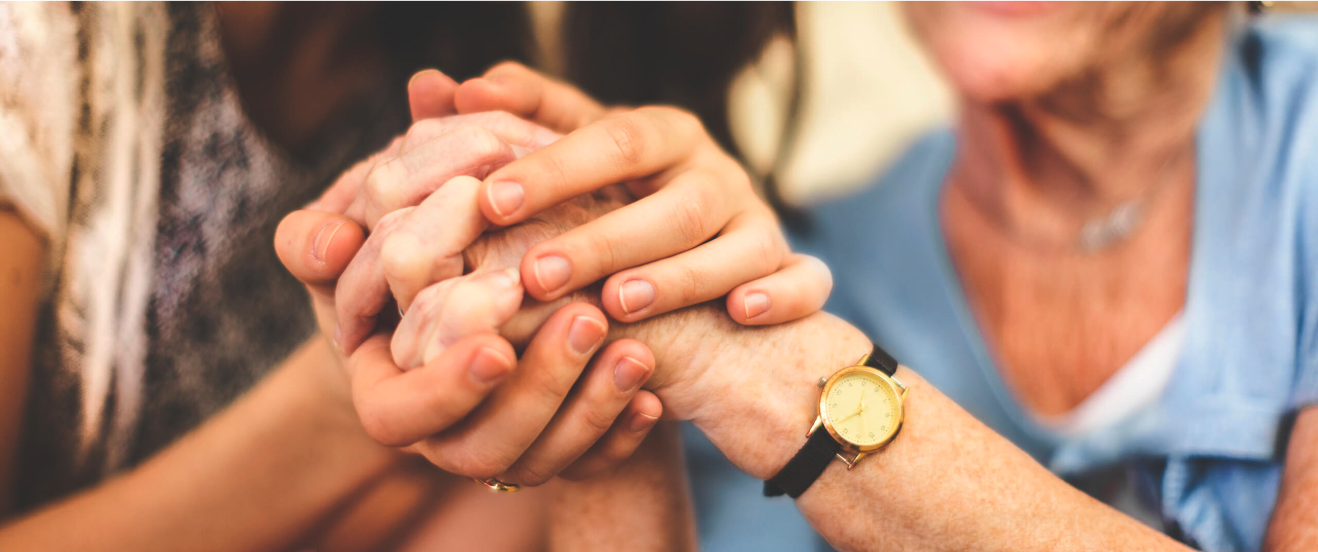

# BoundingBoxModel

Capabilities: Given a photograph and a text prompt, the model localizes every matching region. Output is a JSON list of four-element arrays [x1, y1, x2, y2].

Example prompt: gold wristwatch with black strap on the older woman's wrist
[[764, 345, 907, 498]]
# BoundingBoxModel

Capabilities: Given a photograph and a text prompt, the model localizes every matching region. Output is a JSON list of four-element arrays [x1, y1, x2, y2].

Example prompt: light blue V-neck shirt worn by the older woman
[[688, 17, 1318, 552]]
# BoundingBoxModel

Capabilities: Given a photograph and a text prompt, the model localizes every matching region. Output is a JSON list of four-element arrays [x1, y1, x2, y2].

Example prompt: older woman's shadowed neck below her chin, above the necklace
[[953, 14, 1226, 217]]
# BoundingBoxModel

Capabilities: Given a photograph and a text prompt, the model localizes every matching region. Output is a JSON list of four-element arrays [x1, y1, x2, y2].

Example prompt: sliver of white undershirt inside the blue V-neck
[[1036, 314, 1185, 437]]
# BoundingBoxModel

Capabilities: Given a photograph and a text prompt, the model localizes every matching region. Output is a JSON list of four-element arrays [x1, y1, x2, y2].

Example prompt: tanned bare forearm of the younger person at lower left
[[0, 340, 397, 551]]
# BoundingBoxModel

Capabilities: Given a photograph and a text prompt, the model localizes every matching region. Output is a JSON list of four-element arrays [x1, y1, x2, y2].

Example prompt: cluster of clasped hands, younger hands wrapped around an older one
[[275, 63, 832, 485]]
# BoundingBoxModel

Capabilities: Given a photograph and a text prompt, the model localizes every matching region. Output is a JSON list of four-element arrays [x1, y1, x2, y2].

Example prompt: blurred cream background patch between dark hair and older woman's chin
[[730, 1, 953, 203]]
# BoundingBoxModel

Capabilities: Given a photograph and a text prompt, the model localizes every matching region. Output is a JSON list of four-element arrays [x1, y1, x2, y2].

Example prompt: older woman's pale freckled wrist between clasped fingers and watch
[[638, 306, 871, 478]]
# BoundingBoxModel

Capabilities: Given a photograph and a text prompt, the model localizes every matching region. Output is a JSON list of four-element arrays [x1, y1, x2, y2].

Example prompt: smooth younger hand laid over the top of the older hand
[[448, 63, 832, 324]]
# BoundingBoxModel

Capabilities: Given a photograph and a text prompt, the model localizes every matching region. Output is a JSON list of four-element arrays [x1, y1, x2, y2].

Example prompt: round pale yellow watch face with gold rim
[[820, 369, 902, 448]]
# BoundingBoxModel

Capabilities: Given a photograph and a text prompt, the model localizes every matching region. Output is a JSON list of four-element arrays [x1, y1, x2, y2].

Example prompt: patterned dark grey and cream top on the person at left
[[0, 3, 407, 509]]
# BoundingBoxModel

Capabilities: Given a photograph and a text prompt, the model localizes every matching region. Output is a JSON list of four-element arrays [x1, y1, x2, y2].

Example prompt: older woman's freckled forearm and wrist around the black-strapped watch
[[660, 314, 1186, 551]]
